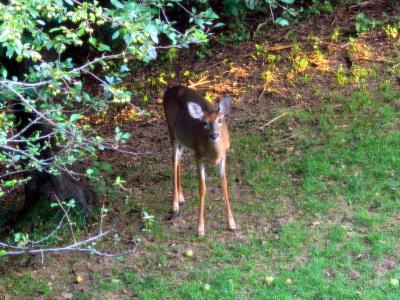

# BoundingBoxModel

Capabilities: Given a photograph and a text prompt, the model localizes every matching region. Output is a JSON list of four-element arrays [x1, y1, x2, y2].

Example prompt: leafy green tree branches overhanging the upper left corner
[[0, 0, 217, 197]]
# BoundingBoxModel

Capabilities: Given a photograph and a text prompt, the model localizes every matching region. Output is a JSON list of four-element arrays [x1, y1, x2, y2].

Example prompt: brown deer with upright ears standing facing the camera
[[163, 86, 237, 236]]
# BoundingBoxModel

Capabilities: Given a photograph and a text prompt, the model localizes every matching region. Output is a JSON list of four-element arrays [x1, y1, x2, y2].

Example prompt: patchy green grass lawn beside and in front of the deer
[[0, 81, 400, 299]]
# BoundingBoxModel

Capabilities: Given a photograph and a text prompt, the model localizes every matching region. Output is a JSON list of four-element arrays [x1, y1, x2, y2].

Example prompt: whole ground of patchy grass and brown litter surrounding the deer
[[0, 1, 400, 299]]
